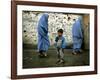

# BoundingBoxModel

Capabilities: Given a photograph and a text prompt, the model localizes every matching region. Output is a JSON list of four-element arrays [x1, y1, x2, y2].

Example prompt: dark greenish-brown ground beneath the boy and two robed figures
[[23, 46, 89, 68]]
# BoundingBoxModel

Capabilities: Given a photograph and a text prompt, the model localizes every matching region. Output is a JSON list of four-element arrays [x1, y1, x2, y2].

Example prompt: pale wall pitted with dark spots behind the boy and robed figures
[[22, 11, 81, 45]]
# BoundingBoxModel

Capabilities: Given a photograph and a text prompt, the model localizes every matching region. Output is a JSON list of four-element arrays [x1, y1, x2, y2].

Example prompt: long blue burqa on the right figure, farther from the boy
[[72, 18, 83, 50]]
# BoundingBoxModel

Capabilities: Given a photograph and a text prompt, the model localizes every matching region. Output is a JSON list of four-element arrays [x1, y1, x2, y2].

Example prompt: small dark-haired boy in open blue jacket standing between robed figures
[[55, 29, 66, 64]]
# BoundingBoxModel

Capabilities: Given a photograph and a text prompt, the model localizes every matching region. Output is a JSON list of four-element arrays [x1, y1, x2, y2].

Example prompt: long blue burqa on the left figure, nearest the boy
[[38, 14, 50, 51]]
